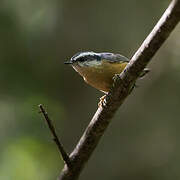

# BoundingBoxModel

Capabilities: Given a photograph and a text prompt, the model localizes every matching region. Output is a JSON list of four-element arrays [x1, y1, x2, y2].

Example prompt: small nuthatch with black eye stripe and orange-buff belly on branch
[[65, 52, 149, 93]]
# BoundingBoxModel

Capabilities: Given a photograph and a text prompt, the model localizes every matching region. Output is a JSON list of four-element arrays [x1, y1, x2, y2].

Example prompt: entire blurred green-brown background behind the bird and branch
[[0, 0, 180, 180]]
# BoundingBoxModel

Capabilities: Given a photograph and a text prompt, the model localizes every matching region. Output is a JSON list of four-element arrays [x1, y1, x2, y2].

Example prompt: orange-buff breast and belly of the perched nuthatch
[[73, 61, 127, 92]]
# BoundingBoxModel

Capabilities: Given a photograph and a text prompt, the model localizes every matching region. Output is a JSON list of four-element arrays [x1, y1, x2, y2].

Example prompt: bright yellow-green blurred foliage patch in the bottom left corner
[[0, 137, 63, 180]]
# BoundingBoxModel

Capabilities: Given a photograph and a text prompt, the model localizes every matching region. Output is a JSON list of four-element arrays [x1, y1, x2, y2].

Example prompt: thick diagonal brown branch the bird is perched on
[[59, 0, 180, 180]]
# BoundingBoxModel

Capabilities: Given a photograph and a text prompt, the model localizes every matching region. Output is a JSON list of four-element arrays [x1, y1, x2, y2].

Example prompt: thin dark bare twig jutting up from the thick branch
[[39, 104, 71, 168]]
